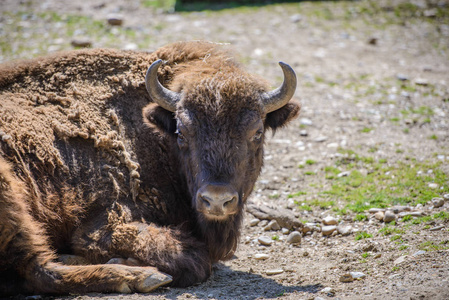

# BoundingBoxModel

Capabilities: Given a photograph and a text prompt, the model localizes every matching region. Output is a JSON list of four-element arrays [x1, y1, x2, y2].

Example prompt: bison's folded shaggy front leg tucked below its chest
[[74, 222, 212, 287]]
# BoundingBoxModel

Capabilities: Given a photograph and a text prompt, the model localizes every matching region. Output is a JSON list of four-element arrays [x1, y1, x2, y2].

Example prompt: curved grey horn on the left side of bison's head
[[145, 59, 181, 112]]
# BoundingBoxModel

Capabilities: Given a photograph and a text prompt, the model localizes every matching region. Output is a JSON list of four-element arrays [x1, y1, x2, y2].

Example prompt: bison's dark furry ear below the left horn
[[142, 103, 176, 134]]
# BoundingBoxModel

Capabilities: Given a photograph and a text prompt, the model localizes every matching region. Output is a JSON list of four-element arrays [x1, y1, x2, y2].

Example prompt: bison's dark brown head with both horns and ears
[[144, 60, 299, 258]]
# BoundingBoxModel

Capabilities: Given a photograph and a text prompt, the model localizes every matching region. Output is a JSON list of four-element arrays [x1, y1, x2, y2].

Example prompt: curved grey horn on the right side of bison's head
[[262, 62, 296, 113]]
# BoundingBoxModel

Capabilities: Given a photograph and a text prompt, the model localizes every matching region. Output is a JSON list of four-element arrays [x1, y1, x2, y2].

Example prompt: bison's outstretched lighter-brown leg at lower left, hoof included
[[0, 158, 171, 297]]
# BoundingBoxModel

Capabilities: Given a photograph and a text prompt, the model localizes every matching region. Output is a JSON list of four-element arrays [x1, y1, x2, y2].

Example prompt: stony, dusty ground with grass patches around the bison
[[0, 0, 449, 299]]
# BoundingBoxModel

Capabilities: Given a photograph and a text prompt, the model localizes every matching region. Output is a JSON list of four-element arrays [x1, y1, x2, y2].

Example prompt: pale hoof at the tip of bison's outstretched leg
[[116, 265, 172, 293]]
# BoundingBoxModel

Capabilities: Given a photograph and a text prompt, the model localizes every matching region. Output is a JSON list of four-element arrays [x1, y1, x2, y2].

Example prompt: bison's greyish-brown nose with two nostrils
[[196, 184, 239, 219]]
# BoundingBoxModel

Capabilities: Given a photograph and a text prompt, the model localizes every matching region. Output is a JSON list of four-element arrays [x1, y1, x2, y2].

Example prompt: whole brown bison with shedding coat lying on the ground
[[0, 42, 300, 295]]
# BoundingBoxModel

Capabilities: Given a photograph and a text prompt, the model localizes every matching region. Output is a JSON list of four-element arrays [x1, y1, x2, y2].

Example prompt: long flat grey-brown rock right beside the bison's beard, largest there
[[246, 203, 303, 229]]
